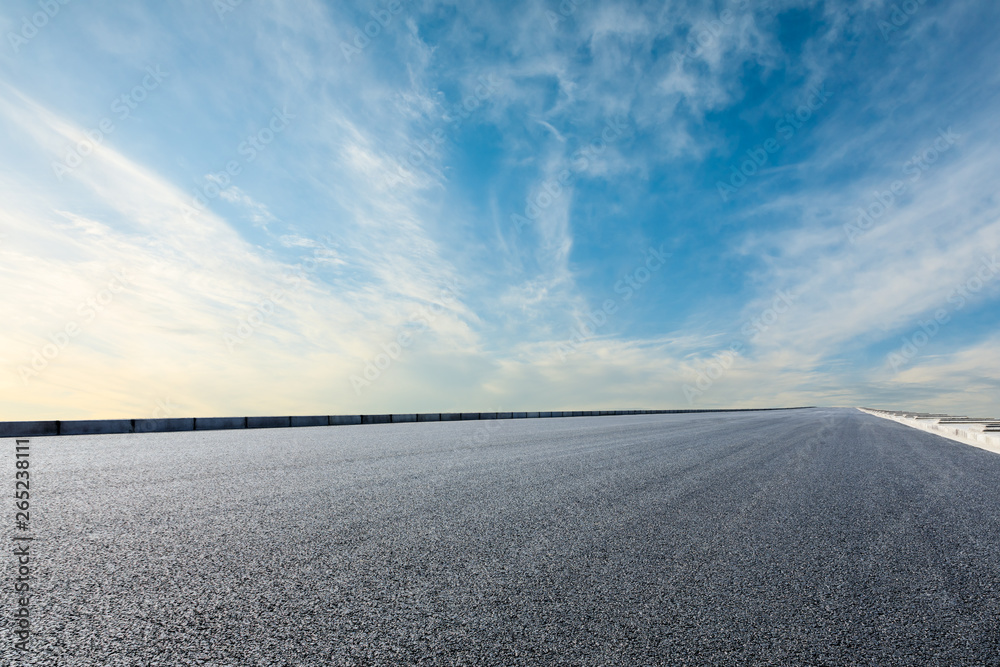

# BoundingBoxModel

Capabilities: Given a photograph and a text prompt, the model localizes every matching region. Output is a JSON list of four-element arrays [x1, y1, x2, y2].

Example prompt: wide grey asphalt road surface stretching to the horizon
[[0, 409, 1000, 667]]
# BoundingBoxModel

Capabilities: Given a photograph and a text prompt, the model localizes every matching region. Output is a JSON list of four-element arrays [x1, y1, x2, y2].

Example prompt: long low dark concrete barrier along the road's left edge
[[0, 406, 812, 438]]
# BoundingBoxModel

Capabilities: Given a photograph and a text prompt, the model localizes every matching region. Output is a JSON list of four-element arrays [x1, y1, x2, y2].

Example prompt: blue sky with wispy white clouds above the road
[[0, 0, 1000, 420]]
